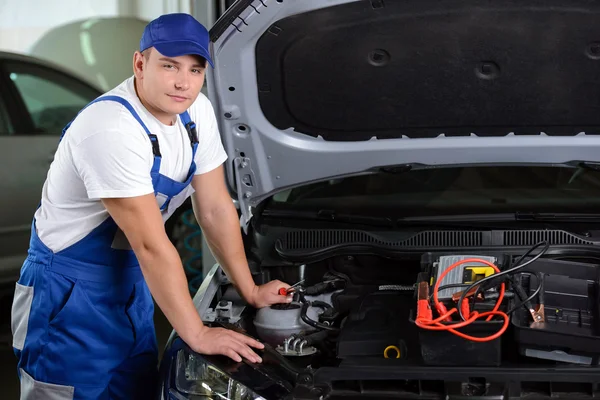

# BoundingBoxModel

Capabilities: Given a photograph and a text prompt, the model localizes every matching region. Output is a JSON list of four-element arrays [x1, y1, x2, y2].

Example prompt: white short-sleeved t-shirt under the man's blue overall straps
[[35, 76, 227, 252]]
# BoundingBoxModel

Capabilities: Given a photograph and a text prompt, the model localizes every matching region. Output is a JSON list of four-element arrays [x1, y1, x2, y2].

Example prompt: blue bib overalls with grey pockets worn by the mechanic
[[12, 96, 198, 400]]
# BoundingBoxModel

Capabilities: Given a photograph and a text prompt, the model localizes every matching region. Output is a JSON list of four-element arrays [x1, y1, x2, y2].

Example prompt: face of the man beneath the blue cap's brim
[[140, 48, 206, 115]]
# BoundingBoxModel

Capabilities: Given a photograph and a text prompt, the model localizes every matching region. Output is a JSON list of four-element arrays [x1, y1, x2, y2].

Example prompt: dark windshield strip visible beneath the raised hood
[[267, 166, 600, 217]]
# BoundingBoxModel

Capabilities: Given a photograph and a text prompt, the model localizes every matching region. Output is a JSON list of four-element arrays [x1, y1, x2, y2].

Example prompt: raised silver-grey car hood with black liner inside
[[207, 0, 600, 223]]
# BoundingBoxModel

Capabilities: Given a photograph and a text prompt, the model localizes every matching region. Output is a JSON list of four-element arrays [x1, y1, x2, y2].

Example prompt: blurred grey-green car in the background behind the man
[[0, 52, 102, 295]]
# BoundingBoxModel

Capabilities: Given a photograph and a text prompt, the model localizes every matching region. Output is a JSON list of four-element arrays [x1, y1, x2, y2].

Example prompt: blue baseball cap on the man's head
[[140, 13, 215, 68]]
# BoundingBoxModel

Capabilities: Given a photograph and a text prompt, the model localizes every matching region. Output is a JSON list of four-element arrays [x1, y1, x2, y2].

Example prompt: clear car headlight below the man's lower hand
[[175, 348, 265, 400]]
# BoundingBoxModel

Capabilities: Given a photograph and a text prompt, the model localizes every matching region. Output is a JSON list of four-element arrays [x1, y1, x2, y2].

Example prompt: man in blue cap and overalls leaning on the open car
[[12, 14, 291, 399]]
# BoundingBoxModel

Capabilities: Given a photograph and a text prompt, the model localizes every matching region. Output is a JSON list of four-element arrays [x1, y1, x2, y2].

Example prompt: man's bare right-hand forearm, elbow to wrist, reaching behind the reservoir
[[194, 200, 256, 303]]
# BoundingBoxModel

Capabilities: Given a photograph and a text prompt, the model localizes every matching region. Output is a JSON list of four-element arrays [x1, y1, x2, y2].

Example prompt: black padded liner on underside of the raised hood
[[256, 0, 600, 140]]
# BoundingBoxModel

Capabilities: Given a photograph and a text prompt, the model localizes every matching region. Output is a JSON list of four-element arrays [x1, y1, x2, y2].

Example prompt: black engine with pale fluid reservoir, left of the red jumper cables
[[245, 256, 436, 366]]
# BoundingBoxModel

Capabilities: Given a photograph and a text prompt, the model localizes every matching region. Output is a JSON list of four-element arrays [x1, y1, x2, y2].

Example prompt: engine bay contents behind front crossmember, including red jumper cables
[[209, 246, 600, 367]]
